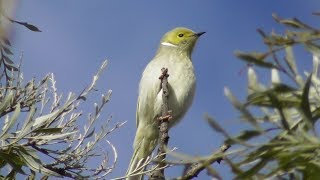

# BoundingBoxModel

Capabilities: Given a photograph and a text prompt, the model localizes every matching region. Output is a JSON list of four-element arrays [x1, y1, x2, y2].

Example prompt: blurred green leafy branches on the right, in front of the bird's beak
[[125, 13, 320, 179]]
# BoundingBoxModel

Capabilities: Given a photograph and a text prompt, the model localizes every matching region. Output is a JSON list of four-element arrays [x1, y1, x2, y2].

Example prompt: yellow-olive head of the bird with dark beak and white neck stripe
[[160, 27, 205, 55]]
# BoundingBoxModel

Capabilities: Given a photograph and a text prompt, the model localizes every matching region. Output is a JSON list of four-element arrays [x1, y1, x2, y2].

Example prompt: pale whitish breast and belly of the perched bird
[[138, 52, 195, 126]]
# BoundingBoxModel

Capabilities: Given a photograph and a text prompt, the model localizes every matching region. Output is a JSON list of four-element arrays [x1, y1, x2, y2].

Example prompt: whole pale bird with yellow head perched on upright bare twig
[[126, 27, 205, 180]]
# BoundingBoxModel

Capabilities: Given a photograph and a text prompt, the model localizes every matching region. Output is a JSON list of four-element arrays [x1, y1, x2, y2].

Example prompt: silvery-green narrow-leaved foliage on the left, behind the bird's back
[[0, 1, 124, 179]]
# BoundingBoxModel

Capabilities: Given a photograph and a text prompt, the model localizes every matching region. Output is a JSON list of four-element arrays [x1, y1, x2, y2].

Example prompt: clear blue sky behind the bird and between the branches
[[11, 0, 320, 179]]
